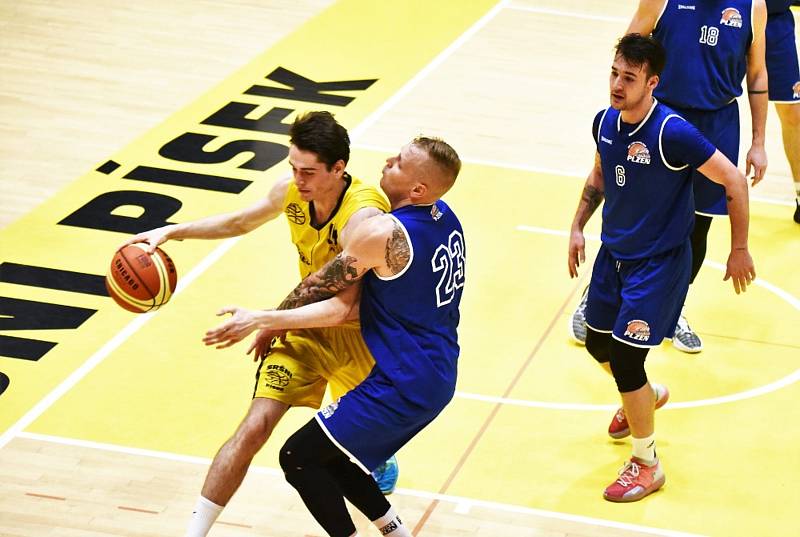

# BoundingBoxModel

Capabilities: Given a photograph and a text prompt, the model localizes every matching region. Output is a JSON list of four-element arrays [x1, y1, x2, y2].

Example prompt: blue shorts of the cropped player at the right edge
[[766, 11, 800, 103]]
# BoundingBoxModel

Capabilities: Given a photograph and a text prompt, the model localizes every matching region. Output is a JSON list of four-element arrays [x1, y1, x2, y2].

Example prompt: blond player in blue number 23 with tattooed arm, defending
[[204, 137, 466, 537]]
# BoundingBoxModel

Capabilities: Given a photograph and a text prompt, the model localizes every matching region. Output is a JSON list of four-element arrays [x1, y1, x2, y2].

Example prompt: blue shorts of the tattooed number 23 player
[[315, 366, 455, 472]]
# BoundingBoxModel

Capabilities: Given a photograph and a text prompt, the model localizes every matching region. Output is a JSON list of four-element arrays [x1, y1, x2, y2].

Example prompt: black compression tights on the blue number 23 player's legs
[[279, 419, 391, 537]]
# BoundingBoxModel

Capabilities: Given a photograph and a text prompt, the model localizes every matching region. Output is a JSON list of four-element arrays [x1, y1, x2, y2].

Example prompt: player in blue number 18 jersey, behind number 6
[[569, 0, 768, 353]]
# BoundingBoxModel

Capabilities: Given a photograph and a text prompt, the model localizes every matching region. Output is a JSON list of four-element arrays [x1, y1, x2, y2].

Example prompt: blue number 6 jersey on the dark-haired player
[[593, 99, 715, 260]]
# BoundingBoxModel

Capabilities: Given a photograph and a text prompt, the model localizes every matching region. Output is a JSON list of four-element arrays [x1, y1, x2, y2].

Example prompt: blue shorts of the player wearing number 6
[[586, 241, 692, 348]]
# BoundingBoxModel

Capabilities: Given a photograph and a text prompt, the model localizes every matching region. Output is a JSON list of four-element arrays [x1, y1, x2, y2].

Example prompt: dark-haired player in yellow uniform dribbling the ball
[[126, 112, 397, 537]]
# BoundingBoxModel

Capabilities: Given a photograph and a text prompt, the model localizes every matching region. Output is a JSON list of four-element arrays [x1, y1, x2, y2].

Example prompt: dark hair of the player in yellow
[[289, 112, 350, 171]]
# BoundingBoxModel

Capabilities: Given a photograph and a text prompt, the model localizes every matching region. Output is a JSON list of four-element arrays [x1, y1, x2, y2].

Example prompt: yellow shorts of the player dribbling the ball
[[253, 327, 375, 408]]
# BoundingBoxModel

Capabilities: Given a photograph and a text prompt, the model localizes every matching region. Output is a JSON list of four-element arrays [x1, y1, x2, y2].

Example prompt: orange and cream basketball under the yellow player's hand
[[106, 244, 178, 313]]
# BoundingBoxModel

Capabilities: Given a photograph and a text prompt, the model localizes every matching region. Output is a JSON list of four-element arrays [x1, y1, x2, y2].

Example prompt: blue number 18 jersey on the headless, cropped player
[[653, 0, 753, 110]]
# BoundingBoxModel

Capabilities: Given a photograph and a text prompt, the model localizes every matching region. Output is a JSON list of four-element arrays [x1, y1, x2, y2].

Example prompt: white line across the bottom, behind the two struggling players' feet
[[17, 432, 702, 537]]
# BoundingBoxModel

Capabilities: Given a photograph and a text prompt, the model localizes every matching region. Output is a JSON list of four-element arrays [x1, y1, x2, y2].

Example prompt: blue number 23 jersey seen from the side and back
[[360, 200, 466, 407]]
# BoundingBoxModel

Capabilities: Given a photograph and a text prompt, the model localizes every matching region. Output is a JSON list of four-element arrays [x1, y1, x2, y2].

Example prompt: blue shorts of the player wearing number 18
[[671, 100, 739, 216]]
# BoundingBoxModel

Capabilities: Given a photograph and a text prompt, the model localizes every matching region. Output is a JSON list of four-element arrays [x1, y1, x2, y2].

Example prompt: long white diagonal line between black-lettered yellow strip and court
[[0, 0, 509, 448]]
